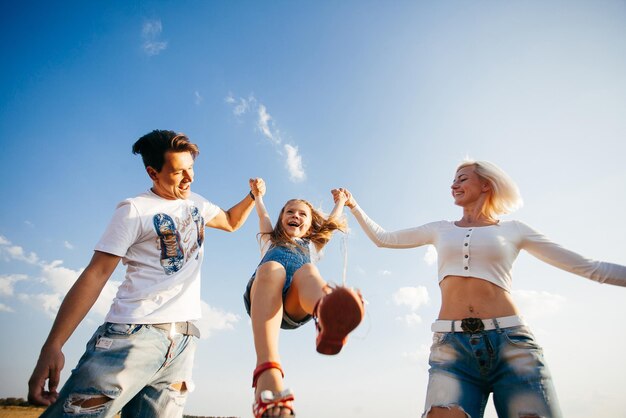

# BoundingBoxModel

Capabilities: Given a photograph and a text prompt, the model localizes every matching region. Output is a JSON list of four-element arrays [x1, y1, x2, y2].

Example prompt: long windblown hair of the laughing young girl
[[262, 199, 346, 248]]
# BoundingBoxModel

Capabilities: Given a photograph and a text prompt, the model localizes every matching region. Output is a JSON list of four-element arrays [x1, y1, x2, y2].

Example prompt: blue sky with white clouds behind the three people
[[0, 0, 626, 418]]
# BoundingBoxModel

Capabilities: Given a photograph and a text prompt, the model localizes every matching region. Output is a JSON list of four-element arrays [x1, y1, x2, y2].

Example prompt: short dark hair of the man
[[133, 129, 200, 172]]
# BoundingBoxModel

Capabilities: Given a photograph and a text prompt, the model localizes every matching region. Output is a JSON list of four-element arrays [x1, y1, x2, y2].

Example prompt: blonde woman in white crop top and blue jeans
[[333, 161, 626, 418]]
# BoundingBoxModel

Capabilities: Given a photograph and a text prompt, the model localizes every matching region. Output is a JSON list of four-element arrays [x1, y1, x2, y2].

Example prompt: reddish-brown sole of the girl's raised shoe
[[313, 286, 365, 355]]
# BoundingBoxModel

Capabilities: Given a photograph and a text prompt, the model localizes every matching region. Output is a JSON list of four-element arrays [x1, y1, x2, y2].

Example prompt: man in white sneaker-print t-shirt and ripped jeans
[[28, 130, 265, 418]]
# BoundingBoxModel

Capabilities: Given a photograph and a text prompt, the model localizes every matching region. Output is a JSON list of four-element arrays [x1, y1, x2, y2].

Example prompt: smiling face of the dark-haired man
[[146, 151, 194, 200]]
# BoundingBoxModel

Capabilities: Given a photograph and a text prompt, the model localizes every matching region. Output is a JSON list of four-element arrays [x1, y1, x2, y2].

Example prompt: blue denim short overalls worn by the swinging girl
[[243, 245, 312, 329]]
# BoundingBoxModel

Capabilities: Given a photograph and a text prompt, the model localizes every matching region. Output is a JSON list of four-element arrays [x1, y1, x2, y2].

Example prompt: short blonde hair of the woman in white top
[[456, 160, 523, 218]]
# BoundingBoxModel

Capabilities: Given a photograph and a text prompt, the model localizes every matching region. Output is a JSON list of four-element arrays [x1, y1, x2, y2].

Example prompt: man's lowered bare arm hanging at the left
[[28, 251, 120, 405]]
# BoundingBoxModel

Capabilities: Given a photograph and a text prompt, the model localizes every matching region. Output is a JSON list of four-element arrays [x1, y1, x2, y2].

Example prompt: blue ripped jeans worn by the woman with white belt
[[423, 326, 561, 418]]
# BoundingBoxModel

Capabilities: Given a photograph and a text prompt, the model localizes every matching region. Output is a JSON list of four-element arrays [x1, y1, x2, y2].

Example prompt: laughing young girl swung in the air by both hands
[[244, 184, 364, 418]]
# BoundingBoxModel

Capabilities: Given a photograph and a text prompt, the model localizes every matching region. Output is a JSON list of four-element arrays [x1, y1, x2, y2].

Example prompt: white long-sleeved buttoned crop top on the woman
[[352, 205, 626, 292]]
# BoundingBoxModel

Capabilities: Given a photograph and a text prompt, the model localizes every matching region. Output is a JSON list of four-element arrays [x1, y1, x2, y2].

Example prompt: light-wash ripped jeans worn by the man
[[41, 322, 196, 418]]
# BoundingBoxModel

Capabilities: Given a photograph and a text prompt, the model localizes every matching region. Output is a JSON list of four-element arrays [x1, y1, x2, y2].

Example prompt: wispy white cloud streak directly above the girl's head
[[224, 93, 306, 183]]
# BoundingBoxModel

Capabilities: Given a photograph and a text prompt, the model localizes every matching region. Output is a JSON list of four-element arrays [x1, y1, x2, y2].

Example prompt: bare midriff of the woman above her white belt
[[439, 276, 519, 319]]
